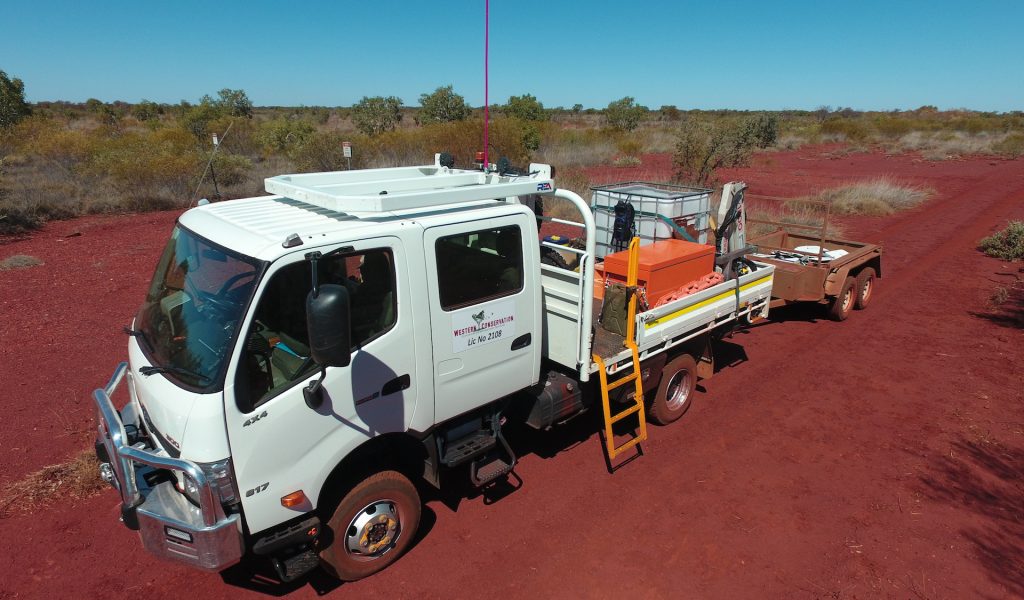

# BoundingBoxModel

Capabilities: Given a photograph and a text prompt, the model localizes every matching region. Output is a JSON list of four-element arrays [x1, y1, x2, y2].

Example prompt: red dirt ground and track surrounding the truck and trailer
[[0, 148, 1024, 599]]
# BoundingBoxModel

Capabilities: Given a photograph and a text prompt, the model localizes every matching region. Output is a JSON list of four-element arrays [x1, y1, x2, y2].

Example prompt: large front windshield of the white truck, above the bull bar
[[135, 226, 261, 388]]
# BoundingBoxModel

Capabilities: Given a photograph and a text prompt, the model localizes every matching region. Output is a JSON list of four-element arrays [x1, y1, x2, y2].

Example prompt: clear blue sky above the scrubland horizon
[[0, 0, 1024, 111]]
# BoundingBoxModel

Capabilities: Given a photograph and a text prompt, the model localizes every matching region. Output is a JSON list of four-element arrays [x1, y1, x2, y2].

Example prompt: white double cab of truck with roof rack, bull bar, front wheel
[[94, 156, 582, 578]]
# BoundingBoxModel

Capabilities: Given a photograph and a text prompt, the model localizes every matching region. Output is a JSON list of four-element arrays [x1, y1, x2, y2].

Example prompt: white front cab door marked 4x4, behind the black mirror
[[224, 238, 421, 532]]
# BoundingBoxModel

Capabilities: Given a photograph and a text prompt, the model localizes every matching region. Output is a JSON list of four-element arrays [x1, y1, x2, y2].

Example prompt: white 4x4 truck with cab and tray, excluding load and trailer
[[93, 155, 773, 581]]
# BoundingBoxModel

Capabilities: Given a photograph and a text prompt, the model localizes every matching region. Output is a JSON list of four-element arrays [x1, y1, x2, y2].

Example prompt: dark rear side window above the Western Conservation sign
[[434, 225, 523, 310]]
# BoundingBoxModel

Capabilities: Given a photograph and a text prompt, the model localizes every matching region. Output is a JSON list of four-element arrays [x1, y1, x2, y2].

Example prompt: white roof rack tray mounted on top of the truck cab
[[264, 155, 555, 213]]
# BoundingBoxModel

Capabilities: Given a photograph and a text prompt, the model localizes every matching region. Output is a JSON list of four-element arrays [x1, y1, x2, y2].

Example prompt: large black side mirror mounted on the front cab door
[[306, 284, 352, 368]]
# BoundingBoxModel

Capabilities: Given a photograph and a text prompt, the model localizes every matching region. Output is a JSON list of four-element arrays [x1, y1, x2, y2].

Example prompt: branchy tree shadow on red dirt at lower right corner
[[921, 437, 1024, 598]]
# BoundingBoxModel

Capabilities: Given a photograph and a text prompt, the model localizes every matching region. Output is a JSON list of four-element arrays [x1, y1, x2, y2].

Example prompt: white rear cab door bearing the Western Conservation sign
[[424, 213, 541, 423]]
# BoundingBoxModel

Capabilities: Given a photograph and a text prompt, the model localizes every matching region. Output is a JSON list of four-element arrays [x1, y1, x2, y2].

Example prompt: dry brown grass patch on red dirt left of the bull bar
[[0, 451, 105, 517]]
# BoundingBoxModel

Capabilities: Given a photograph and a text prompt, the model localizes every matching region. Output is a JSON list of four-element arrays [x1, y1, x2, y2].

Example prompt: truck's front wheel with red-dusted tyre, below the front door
[[321, 471, 421, 582]]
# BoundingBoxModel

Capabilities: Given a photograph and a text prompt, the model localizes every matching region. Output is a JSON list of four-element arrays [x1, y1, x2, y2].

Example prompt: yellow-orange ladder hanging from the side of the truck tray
[[594, 238, 647, 464]]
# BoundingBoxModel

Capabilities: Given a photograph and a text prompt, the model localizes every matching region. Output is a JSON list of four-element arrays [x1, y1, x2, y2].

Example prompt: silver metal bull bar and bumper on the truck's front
[[92, 362, 244, 571]]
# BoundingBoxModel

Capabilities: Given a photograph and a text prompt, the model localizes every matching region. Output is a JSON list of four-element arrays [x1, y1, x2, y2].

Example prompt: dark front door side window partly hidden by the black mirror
[[236, 249, 397, 408]]
